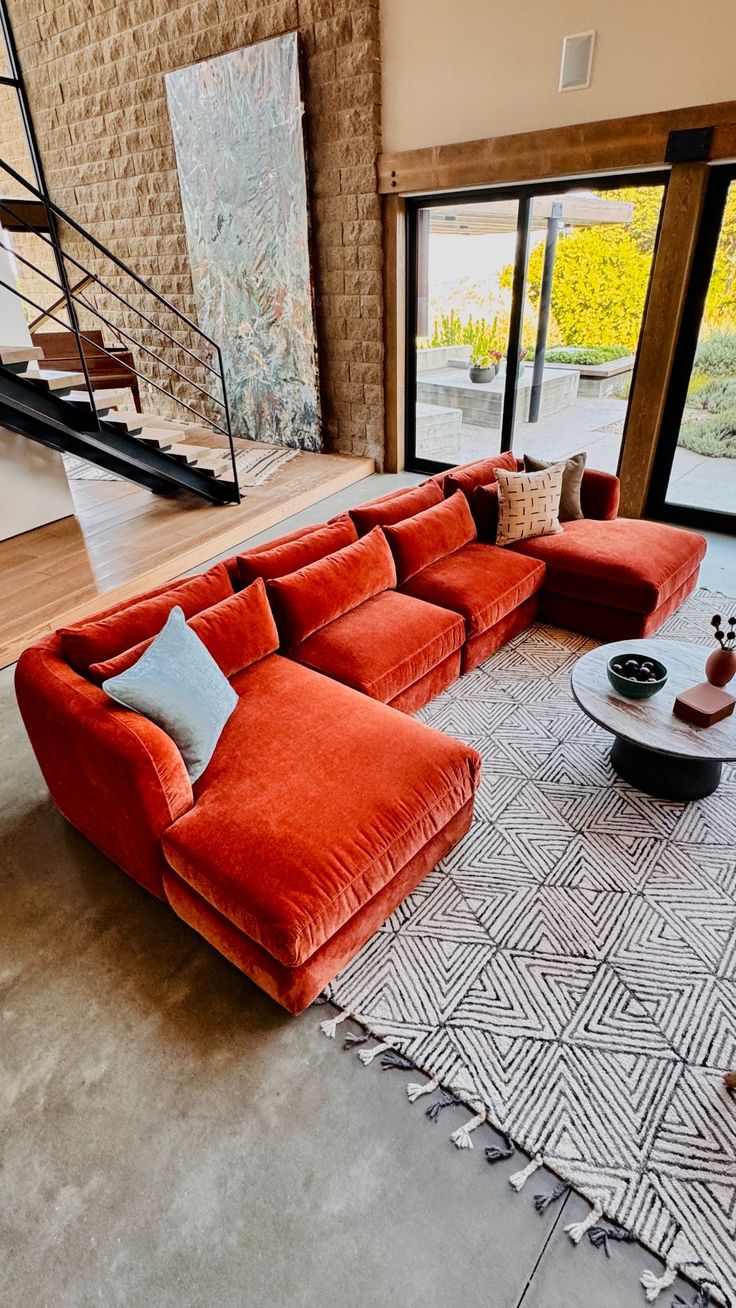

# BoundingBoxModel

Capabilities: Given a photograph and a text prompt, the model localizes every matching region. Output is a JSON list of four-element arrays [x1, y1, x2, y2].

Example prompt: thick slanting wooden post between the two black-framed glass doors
[[620, 164, 709, 518]]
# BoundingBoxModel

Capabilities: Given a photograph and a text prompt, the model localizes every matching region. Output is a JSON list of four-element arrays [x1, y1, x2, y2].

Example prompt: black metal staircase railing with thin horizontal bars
[[0, 160, 239, 501]]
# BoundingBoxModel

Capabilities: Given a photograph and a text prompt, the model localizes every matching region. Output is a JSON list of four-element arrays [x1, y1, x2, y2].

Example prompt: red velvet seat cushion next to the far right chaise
[[401, 542, 544, 638]]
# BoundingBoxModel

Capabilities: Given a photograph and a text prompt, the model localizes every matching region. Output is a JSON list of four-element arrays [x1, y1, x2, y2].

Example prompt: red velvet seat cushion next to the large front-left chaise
[[292, 590, 465, 704]]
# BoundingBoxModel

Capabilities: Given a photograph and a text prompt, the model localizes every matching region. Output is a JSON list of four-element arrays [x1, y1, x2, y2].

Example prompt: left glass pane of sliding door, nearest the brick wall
[[416, 199, 519, 463]]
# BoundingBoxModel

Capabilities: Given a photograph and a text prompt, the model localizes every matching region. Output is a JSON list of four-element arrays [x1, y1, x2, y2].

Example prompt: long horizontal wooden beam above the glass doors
[[378, 101, 736, 195]]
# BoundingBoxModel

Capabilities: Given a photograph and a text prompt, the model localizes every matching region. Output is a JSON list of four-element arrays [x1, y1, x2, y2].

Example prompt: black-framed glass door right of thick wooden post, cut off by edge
[[647, 165, 736, 531]]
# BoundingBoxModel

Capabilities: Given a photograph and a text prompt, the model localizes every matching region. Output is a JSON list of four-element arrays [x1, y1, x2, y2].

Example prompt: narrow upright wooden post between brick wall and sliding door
[[383, 195, 407, 472]]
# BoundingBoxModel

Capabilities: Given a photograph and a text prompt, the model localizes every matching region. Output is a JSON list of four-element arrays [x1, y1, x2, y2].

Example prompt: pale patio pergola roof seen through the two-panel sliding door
[[429, 191, 634, 237]]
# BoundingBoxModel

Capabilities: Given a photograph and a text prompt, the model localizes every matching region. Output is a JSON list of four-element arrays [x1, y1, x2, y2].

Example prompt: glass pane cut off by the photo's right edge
[[667, 182, 736, 514]]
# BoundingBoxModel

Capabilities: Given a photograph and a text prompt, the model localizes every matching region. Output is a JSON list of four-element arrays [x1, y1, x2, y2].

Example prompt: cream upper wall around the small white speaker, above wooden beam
[[380, 0, 736, 150]]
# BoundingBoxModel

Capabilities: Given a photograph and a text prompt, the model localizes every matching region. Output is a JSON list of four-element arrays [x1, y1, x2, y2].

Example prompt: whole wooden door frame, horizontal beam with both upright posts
[[376, 101, 736, 517]]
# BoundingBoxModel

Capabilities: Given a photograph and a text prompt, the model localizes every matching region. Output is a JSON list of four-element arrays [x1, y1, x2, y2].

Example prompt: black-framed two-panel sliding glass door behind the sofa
[[405, 174, 665, 471]]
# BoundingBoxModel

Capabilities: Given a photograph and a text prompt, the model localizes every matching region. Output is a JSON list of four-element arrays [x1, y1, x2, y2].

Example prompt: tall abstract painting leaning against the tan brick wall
[[166, 33, 322, 450]]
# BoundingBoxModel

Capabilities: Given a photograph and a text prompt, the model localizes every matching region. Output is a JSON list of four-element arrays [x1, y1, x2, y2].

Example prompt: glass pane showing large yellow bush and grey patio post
[[505, 184, 664, 472]]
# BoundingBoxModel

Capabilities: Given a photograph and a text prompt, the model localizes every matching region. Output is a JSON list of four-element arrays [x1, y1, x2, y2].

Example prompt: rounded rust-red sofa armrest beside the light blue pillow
[[16, 636, 193, 899]]
